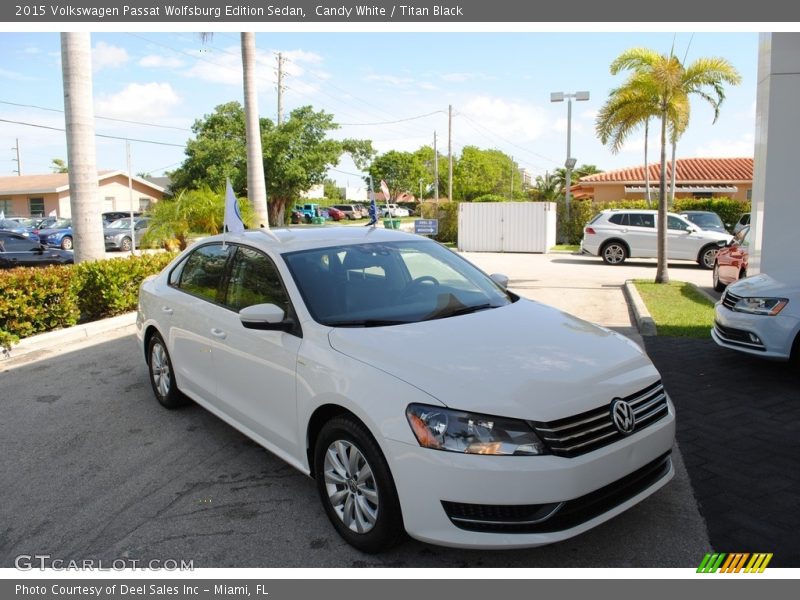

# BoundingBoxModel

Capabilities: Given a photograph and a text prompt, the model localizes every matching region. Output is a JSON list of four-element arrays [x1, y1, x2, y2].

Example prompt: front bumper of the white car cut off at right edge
[[711, 304, 799, 360]]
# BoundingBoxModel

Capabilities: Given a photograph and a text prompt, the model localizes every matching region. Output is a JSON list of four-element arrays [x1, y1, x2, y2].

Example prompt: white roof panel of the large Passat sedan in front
[[203, 226, 418, 254]]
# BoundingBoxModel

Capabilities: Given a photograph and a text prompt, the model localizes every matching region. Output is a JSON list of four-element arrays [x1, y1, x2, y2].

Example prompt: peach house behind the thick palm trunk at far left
[[0, 171, 165, 218]]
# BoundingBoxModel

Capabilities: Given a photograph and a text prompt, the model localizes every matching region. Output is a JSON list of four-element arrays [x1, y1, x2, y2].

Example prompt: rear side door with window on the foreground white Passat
[[164, 243, 231, 403]]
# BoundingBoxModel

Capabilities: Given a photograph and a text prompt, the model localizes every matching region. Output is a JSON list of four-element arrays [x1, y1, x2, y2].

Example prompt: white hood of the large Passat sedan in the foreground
[[329, 300, 659, 421]]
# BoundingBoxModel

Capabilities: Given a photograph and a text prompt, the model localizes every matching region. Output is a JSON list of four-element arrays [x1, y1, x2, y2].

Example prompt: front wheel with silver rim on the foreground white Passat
[[314, 416, 405, 554]]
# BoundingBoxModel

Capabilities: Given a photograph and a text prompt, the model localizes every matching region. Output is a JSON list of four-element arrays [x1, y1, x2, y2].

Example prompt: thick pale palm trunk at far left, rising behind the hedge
[[61, 32, 106, 263]]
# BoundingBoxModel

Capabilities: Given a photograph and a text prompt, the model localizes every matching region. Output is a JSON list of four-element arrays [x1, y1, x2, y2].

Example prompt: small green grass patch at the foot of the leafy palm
[[634, 280, 714, 339]]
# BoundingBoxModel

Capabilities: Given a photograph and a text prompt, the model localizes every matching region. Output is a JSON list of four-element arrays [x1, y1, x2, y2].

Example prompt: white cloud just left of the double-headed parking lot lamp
[[459, 96, 548, 143]]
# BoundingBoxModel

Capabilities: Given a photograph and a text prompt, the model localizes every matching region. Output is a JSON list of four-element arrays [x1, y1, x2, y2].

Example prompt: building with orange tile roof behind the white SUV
[[571, 158, 753, 202]]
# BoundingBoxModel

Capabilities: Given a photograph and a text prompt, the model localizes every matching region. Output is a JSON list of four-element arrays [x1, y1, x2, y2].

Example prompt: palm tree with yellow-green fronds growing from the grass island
[[611, 48, 741, 283]]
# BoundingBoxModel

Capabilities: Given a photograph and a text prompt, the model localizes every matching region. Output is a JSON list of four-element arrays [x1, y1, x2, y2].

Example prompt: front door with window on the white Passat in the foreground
[[210, 246, 302, 457]]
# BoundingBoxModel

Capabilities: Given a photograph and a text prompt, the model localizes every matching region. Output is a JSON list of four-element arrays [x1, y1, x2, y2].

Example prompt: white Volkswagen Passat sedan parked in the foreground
[[137, 227, 675, 552]]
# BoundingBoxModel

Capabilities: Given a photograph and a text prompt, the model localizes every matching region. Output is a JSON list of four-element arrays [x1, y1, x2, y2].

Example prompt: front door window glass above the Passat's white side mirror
[[225, 246, 289, 312]]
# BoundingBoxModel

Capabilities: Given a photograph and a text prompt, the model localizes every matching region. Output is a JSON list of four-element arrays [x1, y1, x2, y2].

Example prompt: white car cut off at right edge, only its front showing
[[711, 273, 800, 369]]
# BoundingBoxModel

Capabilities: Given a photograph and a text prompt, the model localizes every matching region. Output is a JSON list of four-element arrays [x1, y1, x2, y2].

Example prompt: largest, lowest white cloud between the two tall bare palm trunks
[[95, 82, 181, 121]]
